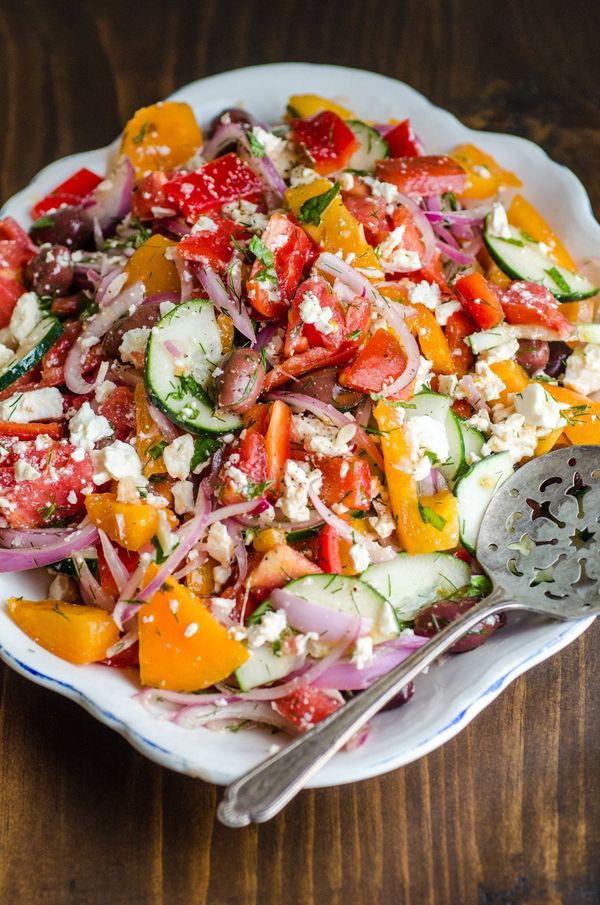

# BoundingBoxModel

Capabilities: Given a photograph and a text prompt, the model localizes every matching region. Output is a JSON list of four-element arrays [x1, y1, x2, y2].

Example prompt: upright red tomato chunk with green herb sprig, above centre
[[246, 213, 313, 317]]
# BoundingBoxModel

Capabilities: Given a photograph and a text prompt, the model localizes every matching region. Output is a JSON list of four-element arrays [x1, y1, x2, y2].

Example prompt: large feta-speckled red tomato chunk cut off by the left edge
[[0, 438, 93, 528]]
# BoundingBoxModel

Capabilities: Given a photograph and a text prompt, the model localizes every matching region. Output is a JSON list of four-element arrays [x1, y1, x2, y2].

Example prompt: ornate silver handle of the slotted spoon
[[218, 588, 523, 827]]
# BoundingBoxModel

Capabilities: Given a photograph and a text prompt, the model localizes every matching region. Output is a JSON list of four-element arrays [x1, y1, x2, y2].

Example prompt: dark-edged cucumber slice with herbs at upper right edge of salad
[[483, 215, 598, 302]]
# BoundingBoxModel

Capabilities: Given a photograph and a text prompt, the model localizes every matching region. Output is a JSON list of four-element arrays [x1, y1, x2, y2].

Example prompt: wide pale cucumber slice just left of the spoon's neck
[[362, 553, 471, 622]]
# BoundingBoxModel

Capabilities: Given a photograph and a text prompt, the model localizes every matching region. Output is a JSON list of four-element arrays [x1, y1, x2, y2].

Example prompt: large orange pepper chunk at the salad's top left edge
[[121, 101, 202, 179]]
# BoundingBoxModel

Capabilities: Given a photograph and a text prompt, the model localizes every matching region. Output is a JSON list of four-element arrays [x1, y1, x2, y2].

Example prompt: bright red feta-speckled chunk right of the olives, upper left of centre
[[164, 153, 262, 222]]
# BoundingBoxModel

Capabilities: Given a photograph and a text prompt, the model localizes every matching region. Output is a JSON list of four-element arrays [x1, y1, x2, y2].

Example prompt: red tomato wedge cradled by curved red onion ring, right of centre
[[338, 329, 406, 393]]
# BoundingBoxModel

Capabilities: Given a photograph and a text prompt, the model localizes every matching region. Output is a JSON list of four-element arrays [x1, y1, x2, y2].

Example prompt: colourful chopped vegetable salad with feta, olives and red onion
[[0, 95, 600, 744]]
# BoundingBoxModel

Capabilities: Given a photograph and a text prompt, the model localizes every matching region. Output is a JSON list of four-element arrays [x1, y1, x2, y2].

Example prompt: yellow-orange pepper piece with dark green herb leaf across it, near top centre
[[285, 179, 381, 276]]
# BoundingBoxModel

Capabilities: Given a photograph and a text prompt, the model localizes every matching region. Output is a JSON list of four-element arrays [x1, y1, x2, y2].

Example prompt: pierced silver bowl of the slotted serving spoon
[[477, 446, 600, 619]]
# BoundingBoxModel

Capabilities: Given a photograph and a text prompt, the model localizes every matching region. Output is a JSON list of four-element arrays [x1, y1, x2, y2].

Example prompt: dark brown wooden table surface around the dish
[[0, 0, 600, 905]]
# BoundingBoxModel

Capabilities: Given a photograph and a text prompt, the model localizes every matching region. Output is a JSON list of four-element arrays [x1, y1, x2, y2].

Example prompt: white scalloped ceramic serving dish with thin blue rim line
[[0, 63, 600, 786]]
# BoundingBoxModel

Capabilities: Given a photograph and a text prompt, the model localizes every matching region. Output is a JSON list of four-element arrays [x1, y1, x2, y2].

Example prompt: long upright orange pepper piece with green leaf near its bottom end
[[374, 400, 459, 553]]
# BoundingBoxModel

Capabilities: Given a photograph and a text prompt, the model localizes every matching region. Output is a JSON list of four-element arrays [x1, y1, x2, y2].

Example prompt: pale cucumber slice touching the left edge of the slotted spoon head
[[454, 452, 514, 553]]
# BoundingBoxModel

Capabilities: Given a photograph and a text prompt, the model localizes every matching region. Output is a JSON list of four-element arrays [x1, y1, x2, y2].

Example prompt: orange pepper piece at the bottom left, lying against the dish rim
[[8, 597, 119, 664]]
